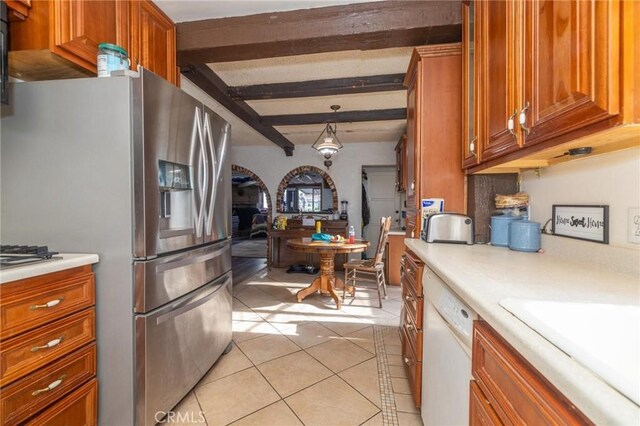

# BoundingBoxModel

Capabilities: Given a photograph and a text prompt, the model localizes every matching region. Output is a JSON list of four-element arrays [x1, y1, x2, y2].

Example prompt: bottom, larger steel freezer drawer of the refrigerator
[[135, 272, 232, 425]]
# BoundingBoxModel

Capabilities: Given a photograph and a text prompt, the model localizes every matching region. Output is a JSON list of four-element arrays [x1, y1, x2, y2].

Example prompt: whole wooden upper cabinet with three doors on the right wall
[[462, 0, 640, 173]]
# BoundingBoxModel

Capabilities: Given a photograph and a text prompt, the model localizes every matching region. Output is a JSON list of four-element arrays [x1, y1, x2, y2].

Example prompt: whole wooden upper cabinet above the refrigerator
[[9, 0, 178, 84]]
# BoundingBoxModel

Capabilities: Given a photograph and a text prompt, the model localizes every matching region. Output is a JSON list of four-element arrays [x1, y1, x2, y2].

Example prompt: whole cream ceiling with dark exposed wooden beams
[[157, 1, 461, 155]]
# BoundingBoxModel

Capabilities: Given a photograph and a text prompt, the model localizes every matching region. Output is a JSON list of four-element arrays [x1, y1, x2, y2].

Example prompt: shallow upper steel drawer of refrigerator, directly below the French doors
[[133, 240, 231, 313]]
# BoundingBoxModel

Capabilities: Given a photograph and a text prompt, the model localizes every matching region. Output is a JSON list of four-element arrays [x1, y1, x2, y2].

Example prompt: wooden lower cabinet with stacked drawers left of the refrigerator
[[0, 265, 97, 426]]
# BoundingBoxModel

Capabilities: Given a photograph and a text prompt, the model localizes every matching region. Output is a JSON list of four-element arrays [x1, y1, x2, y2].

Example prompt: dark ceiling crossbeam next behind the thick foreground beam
[[229, 74, 405, 101]]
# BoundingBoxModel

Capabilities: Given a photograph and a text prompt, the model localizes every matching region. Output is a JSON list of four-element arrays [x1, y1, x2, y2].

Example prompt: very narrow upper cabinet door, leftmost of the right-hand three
[[462, 0, 480, 167]]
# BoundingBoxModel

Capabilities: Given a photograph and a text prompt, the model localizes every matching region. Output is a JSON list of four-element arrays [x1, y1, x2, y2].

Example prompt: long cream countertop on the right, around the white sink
[[405, 239, 640, 425]]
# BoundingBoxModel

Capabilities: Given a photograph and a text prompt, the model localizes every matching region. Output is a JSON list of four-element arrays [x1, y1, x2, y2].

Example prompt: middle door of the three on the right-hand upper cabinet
[[476, 0, 518, 160]]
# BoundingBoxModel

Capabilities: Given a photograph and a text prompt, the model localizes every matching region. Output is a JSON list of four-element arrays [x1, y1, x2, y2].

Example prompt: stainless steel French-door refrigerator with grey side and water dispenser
[[0, 70, 232, 426]]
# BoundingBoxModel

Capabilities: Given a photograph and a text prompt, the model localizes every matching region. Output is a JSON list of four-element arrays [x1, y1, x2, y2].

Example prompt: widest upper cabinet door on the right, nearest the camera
[[518, 0, 620, 145]]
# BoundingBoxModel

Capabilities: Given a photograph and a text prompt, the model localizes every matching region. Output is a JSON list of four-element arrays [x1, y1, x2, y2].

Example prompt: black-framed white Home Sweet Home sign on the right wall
[[551, 204, 609, 244]]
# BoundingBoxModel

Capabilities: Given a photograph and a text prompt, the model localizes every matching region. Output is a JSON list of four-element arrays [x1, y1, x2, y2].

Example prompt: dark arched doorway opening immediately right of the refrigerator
[[231, 164, 272, 238]]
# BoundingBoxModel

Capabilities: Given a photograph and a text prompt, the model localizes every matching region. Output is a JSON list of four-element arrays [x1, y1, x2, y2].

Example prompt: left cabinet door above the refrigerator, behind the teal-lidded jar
[[50, 0, 129, 72]]
